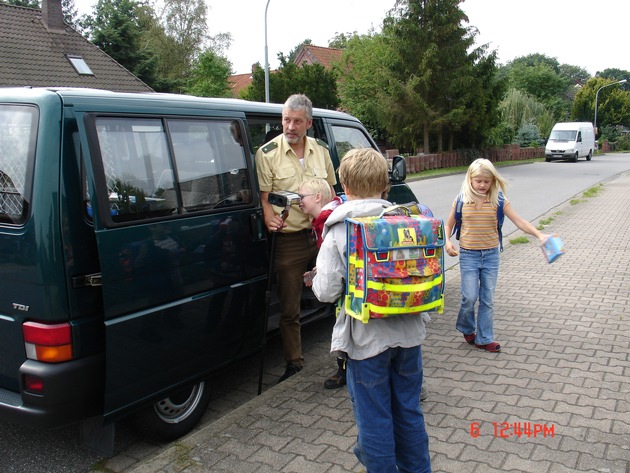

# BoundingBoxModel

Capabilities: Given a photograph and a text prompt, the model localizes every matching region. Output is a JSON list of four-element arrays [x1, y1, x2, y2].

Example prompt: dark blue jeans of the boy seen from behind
[[346, 346, 431, 473]]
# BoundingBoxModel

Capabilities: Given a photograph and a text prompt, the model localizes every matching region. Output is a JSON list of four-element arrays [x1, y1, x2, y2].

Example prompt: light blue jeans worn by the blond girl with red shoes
[[455, 248, 499, 345]]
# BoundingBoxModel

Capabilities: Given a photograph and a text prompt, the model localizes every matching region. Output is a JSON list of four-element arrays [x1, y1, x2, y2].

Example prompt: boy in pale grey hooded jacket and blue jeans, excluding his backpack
[[313, 148, 431, 473]]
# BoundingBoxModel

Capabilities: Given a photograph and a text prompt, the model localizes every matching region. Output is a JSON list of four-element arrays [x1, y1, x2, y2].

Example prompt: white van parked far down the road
[[545, 122, 597, 162]]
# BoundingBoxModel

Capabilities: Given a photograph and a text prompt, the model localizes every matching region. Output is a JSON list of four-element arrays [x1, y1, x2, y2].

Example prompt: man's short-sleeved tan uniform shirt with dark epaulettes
[[256, 134, 337, 232]]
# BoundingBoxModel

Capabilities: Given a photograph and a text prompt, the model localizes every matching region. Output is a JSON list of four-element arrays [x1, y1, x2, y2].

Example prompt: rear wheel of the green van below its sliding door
[[131, 381, 210, 442]]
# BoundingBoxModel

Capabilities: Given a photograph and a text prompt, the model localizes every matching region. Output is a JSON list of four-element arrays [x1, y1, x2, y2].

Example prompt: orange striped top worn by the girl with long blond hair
[[453, 198, 509, 250]]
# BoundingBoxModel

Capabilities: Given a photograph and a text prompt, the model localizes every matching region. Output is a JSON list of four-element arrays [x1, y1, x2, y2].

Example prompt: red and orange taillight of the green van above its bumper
[[22, 322, 72, 363]]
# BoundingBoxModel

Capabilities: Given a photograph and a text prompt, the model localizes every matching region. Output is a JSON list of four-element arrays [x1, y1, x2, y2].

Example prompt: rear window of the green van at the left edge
[[0, 104, 39, 224]]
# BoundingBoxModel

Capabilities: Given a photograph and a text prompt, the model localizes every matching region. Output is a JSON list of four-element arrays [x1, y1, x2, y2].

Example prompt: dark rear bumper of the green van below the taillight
[[0, 354, 105, 428]]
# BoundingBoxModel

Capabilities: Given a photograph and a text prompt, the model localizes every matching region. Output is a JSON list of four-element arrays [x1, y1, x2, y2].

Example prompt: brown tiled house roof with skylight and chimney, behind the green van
[[0, 0, 152, 92]]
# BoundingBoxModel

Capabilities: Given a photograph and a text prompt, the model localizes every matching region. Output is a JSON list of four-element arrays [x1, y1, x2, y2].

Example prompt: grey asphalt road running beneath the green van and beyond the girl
[[0, 153, 630, 473]]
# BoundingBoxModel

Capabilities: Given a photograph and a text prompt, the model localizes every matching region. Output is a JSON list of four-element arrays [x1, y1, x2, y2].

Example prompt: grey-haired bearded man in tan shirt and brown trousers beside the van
[[256, 94, 337, 382]]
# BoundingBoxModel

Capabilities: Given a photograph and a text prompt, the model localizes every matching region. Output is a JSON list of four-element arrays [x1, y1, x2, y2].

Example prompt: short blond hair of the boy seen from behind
[[338, 148, 389, 199]]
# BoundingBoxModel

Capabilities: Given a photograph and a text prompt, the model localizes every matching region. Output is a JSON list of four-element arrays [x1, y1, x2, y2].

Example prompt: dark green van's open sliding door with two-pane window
[[82, 114, 267, 414]]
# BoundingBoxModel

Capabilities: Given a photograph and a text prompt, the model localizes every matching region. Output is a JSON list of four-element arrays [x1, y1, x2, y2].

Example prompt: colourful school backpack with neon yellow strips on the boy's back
[[342, 206, 445, 323]]
